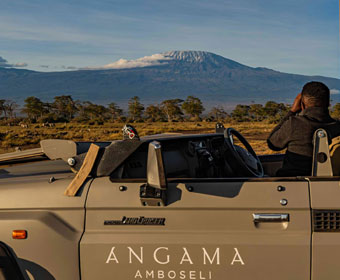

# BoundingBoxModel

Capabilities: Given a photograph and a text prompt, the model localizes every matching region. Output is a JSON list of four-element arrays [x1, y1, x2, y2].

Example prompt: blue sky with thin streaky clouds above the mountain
[[0, 0, 340, 78]]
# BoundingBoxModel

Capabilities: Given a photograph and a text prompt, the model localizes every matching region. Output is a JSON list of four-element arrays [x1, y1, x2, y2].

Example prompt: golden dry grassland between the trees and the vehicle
[[0, 122, 274, 154]]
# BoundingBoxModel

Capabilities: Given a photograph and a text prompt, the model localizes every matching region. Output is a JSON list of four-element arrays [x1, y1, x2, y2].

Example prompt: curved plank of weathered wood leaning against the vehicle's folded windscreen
[[64, 144, 100, 196]]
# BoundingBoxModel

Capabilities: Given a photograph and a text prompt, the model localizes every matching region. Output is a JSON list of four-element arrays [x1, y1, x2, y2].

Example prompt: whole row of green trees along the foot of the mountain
[[0, 95, 340, 124]]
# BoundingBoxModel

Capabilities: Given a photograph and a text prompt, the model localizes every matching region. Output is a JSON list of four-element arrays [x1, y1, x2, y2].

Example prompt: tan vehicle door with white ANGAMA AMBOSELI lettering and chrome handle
[[80, 174, 310, 280]]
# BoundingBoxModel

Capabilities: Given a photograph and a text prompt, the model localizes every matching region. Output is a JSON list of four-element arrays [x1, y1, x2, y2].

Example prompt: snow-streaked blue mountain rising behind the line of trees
[[0, 51, 340, 105]]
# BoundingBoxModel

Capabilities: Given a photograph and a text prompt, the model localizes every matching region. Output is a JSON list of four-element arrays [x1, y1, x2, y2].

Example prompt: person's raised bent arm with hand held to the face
[[267, 93, 302, 151]]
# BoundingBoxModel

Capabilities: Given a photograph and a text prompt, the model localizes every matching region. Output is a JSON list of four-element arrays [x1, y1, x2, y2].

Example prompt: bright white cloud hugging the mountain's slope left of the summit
[[81, 54, 172, 70]]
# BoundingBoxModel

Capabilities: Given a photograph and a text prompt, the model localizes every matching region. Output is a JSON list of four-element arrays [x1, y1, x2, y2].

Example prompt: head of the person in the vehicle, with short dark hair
[[301, 82, 330, 107]]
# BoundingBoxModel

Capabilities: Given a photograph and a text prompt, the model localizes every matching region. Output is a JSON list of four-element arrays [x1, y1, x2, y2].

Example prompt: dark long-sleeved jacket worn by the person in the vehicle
[[267, 107, 340, 176]]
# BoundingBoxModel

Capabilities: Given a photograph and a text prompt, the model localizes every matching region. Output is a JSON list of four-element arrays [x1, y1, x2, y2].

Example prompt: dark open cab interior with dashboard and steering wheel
[[111, 128, 290, 179]]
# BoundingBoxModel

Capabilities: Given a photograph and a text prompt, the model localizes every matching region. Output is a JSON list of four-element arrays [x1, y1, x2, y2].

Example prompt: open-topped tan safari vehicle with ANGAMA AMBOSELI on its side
[[0, 124, 340, 280]]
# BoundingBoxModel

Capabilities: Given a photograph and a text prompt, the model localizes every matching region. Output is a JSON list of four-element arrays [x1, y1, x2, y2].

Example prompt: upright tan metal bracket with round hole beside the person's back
[[312, 128, 333, 176]]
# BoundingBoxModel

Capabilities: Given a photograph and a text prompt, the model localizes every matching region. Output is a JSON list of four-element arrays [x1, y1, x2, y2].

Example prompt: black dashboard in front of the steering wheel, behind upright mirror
[[111, 134, 233, 178]]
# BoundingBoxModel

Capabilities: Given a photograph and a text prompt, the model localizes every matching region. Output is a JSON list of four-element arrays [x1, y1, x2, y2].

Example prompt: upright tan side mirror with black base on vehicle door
[[140, 141, 167, 206]]
